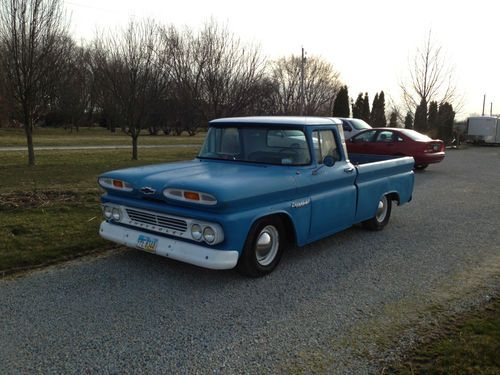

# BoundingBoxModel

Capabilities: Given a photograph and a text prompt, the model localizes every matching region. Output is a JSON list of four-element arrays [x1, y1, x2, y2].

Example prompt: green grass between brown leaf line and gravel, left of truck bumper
[[0, 201, 111, 274]]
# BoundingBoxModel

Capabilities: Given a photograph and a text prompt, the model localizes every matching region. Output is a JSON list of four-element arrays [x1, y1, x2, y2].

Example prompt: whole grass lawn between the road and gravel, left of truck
[[0, 147, 198, 273]]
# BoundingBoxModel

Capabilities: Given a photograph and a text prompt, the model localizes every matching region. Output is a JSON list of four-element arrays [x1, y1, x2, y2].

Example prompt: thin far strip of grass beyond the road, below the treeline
[[0, 128, 206, 147]]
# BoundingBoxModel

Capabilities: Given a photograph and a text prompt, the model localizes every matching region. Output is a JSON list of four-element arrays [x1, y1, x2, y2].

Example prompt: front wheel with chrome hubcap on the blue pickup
[[238, 217, 286, 277]]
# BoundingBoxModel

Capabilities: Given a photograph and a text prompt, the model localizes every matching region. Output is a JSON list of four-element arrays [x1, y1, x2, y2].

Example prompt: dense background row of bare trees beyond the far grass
[[0, 15, 341, 133]]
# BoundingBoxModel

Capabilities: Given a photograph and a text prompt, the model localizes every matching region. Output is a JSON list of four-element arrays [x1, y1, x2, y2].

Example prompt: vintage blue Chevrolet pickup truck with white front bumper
[[99, 117, 414, 276]]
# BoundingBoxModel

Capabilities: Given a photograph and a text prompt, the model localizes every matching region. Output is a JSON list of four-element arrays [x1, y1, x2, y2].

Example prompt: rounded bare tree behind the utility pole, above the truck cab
[[271, 55, 341, 116]]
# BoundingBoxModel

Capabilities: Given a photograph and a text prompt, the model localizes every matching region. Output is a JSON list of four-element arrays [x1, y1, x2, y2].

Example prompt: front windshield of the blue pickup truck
[[198, 127, 311, 165]]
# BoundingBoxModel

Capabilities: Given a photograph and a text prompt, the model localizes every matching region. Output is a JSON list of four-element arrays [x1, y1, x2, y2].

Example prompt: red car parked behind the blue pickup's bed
[[346, 128, 444, 169]]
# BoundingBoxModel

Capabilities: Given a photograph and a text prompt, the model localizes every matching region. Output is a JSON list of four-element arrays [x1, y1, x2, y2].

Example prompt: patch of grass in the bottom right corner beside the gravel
[[384, 299, 500, 375]]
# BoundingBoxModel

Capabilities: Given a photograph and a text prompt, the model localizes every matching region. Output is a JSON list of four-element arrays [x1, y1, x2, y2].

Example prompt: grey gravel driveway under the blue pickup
[[0, 147, 500, 374]]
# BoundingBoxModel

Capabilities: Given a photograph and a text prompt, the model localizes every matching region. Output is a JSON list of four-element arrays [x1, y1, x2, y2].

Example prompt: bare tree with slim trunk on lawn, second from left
[[93, 21, 164, 160]]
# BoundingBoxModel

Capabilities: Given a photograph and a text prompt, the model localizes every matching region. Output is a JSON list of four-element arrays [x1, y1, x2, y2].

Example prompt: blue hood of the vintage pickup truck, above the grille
[[101, 159, 297, 210]]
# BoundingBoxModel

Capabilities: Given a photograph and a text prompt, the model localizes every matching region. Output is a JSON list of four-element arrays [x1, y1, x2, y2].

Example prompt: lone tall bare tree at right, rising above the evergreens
[[400, 31, 462, 112]]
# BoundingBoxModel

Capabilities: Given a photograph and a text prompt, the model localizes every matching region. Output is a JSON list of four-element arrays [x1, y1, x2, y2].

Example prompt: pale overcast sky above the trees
[[64, 0, 500, 117]]
